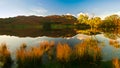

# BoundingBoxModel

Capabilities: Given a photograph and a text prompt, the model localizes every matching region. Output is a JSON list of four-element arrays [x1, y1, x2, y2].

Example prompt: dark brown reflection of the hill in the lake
[[0, 28, 77, 37]]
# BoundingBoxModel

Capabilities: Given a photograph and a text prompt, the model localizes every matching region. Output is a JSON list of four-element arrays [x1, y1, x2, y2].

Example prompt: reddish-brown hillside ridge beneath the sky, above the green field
[[0, 15, 77, 25]]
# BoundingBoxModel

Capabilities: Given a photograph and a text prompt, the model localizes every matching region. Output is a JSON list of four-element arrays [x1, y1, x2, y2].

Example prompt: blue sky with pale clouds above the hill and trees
[[0, 0, 120, 18]]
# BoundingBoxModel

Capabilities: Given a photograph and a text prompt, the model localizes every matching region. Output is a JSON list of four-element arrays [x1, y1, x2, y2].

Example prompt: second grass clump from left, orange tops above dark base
[[16, 44, 44, 68]]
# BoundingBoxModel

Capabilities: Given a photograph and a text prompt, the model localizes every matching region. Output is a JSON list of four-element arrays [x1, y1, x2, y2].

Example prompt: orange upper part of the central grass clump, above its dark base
[[56, 43, 72, 62]]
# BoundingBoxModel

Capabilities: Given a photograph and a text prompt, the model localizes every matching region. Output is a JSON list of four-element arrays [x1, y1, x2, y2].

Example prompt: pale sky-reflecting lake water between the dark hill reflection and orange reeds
[[0, 34, 120, 60]]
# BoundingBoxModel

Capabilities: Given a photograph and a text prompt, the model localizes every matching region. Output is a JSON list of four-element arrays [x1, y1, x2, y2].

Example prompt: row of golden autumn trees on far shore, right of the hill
[[78, 14, 120, 32]]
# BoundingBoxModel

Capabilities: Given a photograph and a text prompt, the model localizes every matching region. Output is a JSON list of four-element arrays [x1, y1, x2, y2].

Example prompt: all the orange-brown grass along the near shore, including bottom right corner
[[0, 38, 120, 68]]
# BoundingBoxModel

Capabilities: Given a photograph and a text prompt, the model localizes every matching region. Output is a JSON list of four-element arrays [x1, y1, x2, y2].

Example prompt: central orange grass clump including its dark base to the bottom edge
[[56, 43, 72, 68]]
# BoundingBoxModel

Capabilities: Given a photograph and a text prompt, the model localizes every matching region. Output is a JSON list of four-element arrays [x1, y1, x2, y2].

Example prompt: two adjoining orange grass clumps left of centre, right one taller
[[16, 41, 54, 68]]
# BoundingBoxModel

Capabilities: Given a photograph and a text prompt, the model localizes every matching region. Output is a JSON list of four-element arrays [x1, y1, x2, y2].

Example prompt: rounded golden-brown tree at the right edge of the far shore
[[99, 14, 120, 33]]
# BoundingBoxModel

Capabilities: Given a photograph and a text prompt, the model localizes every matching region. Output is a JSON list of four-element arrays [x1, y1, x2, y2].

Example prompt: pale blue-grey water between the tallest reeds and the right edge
[[95, 34, 120, 60]]
